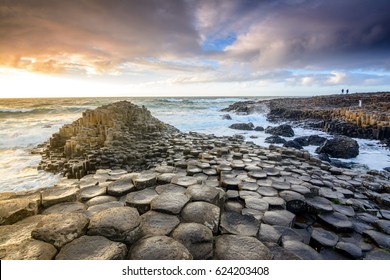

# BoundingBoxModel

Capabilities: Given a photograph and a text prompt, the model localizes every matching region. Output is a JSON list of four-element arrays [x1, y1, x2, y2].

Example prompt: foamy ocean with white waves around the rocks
[[0, 97, 390, 192]]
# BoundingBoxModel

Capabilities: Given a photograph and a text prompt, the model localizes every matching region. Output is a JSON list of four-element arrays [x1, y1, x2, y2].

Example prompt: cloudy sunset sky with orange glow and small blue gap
[[0, 0, 390, 97]]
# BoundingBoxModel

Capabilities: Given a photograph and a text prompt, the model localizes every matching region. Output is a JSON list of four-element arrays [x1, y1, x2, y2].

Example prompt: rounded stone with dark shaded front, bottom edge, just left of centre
[[172, 223, 213, 260]]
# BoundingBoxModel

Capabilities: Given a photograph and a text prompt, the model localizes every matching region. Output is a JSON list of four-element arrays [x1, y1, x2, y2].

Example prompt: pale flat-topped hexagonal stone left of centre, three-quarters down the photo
[[150, 193, 190, 215]]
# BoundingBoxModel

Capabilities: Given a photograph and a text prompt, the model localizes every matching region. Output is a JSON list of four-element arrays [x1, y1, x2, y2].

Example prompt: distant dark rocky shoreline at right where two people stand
[[223, 92, 390, 147]]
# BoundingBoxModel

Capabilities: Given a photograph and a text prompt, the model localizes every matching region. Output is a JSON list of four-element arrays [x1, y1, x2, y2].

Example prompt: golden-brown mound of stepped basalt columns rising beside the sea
[[36, 101, 178, 178]]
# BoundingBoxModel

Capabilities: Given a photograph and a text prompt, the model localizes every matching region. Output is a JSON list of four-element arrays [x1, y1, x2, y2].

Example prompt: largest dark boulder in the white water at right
[[316, 136, 359, 158]]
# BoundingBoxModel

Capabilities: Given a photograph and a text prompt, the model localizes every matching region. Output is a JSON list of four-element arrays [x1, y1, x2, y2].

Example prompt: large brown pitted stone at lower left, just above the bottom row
[[31, 213, 89, 248]]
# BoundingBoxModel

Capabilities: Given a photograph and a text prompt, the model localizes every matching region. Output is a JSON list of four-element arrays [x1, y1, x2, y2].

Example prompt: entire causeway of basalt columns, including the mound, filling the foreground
[[0, 102, 390, 260]]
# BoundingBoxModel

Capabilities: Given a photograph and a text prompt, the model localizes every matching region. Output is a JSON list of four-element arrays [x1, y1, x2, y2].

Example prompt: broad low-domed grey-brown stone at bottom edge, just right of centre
[[215, 234, 273, 260]]
